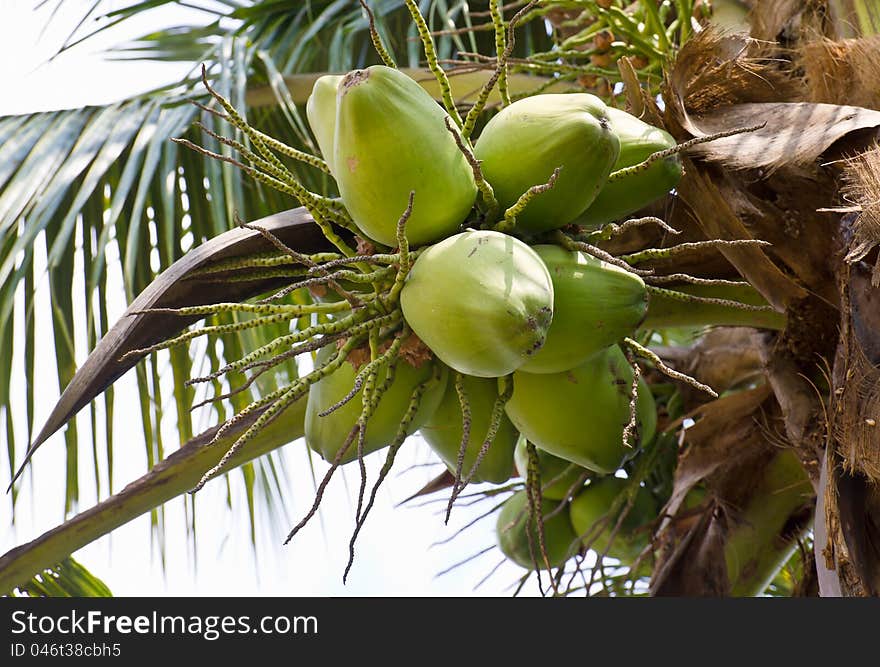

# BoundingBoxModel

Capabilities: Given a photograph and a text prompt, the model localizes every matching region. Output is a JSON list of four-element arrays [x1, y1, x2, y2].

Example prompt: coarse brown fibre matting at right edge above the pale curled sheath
[[795, 35, 880, 109]]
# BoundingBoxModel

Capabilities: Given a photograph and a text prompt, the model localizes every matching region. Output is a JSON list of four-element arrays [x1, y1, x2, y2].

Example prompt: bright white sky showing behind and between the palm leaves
[[0, 0, 537, 596]]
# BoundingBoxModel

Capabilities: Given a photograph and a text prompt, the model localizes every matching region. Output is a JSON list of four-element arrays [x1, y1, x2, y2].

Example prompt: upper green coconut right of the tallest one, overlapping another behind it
[[474, 93, 620, 232]]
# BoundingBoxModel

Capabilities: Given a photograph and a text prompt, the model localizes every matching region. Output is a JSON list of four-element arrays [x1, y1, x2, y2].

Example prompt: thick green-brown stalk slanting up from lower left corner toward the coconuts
[[0, 401, 306, 594]]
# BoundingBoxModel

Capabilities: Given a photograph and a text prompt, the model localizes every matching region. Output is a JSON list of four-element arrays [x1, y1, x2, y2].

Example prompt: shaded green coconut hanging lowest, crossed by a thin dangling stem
[[495, 491, 577, 570]]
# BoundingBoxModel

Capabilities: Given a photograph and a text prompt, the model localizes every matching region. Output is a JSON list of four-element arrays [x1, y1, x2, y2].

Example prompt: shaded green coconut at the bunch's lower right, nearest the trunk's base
[[569, 477, 657, 562]]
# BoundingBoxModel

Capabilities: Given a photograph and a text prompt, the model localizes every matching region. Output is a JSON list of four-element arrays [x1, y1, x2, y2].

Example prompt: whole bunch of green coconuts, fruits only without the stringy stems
[[305, 66, 681, 568]]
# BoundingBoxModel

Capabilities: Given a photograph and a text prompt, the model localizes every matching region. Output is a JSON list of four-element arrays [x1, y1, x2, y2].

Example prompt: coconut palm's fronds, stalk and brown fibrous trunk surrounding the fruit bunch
[[0, 0, 880, 594]]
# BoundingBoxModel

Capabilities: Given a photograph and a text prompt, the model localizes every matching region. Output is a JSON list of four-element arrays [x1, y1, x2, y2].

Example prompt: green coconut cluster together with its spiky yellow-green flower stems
[[165, 3, 764, 588]]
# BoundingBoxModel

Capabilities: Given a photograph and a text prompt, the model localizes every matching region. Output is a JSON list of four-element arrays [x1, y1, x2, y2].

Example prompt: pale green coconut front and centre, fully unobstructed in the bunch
[[400, 231, 553, 377]]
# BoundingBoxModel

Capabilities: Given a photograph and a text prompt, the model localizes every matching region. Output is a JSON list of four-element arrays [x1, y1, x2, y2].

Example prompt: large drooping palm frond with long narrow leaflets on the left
[[0, 38, 327, 548]]
